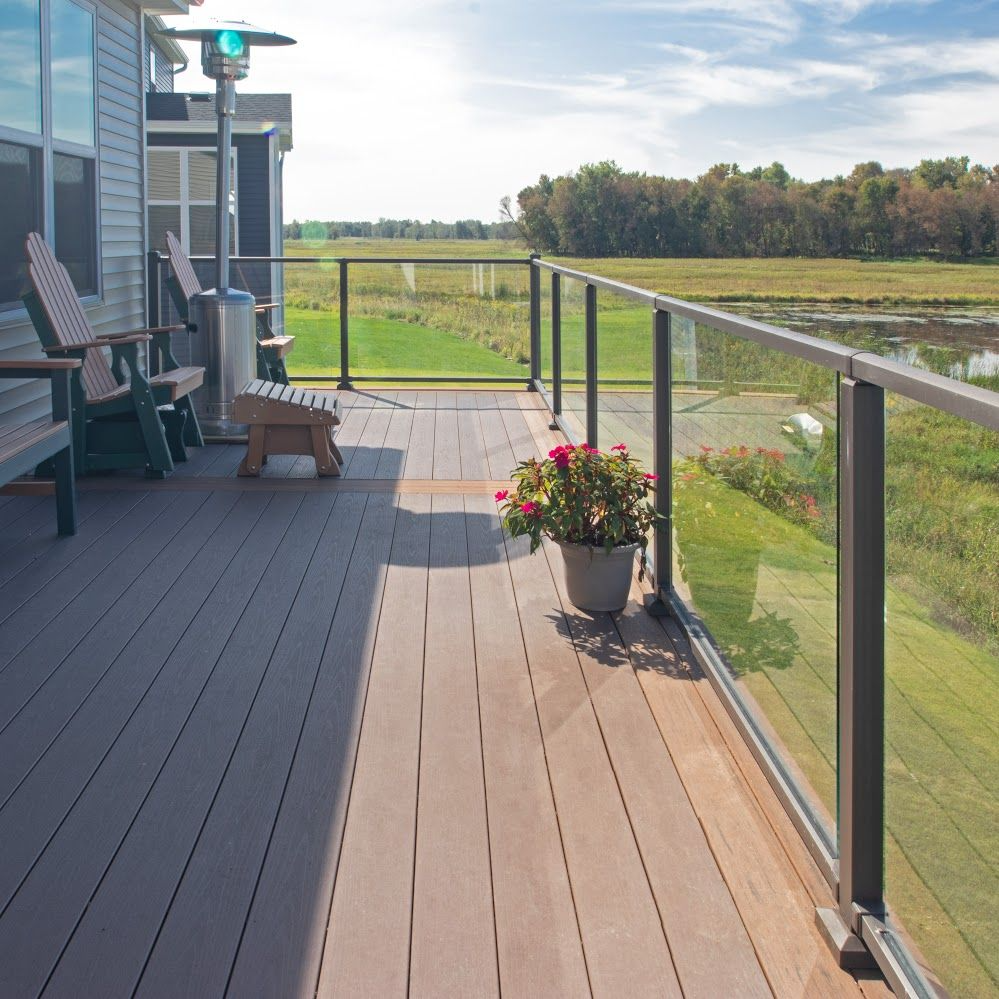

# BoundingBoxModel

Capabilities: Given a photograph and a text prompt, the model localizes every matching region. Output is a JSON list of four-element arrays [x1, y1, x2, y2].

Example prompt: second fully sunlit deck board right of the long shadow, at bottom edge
[[410, 496, 499, 997]]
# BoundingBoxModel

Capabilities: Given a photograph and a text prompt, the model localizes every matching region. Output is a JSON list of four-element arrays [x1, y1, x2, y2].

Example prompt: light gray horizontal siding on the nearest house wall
[[0, 0, 145, 422]]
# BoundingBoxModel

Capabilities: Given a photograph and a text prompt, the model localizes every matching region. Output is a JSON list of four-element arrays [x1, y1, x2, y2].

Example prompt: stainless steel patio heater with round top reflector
[[159, 21, 295, 439]]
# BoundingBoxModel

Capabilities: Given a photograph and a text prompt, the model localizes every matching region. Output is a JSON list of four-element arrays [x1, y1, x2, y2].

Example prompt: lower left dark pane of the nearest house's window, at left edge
[[0, 142, 42, 306]]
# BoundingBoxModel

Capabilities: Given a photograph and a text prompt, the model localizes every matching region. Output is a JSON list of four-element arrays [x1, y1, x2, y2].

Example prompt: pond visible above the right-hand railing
[[721, 303, 999, 381]]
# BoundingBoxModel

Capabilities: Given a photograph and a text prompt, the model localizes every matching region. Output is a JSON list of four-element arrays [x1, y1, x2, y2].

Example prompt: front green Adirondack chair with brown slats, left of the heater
[[23, 232, 205, 478]]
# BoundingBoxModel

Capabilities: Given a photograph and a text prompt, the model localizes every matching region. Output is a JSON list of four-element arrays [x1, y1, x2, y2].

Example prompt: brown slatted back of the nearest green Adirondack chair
[[25, 232, 118, 398]]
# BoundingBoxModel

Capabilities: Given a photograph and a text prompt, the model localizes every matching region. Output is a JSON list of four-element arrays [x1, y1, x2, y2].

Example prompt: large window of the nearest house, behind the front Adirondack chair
[[0, 0, 100, 309]]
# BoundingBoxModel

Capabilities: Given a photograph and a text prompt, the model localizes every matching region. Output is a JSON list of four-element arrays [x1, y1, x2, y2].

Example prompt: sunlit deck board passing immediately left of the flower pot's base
[[507, 539, 681, 997]]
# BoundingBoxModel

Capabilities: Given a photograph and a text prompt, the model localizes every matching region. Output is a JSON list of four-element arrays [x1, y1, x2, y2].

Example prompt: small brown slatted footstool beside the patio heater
[[233, 378, 343, 475]]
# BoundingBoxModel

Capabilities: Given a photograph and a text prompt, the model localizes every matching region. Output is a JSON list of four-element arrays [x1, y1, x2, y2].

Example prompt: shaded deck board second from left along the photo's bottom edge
[[38, 496, 320, 996]]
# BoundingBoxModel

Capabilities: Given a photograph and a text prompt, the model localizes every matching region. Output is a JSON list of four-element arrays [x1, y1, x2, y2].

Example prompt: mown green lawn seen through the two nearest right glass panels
[[678, 479, 999, 997]]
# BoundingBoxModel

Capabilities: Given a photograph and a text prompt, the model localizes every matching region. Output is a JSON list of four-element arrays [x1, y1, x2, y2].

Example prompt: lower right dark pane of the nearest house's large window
[[52, 153, 97, 295]]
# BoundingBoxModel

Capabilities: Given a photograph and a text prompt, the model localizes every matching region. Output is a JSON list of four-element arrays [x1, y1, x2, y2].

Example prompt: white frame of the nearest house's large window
[[0, 0, 104, 319]]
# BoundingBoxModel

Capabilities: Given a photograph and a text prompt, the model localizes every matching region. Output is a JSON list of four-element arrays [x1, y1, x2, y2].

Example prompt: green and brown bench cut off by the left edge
[[0, 358, 82, 534]]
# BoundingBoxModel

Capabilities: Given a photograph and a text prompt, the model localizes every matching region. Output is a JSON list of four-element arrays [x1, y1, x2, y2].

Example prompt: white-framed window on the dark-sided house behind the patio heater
[[148, 147, 239, 256]]
